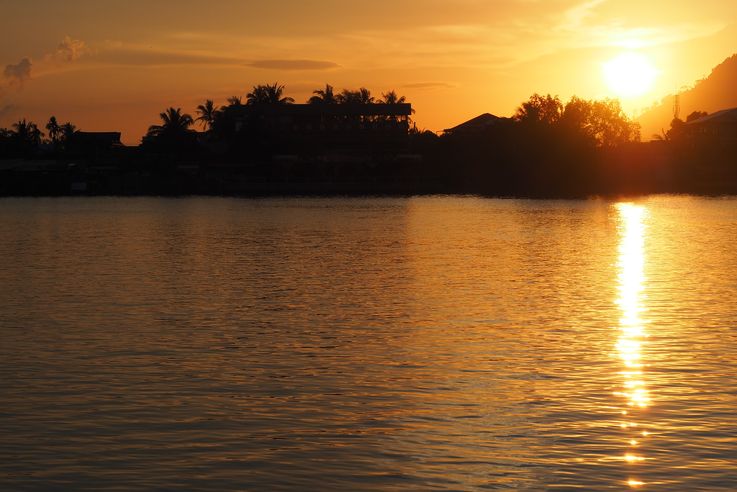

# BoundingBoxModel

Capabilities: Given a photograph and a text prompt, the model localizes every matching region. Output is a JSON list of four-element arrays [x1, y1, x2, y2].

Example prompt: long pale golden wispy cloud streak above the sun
[[320, 0, 726, 71]]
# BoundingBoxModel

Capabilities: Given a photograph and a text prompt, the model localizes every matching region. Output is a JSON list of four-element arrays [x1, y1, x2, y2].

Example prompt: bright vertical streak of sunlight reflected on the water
[[616, 203, 650, 488]]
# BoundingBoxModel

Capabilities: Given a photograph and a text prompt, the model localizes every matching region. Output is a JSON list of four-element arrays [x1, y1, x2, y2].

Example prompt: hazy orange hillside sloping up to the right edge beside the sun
[[638, 54, 737, 140]]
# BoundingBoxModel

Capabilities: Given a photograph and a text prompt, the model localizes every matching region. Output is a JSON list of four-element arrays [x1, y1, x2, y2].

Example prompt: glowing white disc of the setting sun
[[603, 52, 658, 99]]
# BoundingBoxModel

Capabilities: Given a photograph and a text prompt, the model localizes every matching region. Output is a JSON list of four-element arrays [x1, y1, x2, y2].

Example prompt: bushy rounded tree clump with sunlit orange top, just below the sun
[[436, 94, 640, 196]]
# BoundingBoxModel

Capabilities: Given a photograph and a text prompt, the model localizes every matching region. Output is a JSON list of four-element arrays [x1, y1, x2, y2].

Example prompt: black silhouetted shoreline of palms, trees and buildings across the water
[[0, 83, 737, 197]]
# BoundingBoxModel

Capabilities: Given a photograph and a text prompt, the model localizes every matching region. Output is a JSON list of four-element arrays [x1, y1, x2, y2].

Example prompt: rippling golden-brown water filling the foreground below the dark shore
[[0, 197, 737, 491]]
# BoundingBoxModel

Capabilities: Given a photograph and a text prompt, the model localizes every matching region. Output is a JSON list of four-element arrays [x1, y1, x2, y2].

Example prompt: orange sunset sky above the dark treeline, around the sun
[[0, 0, 737, 144]]
